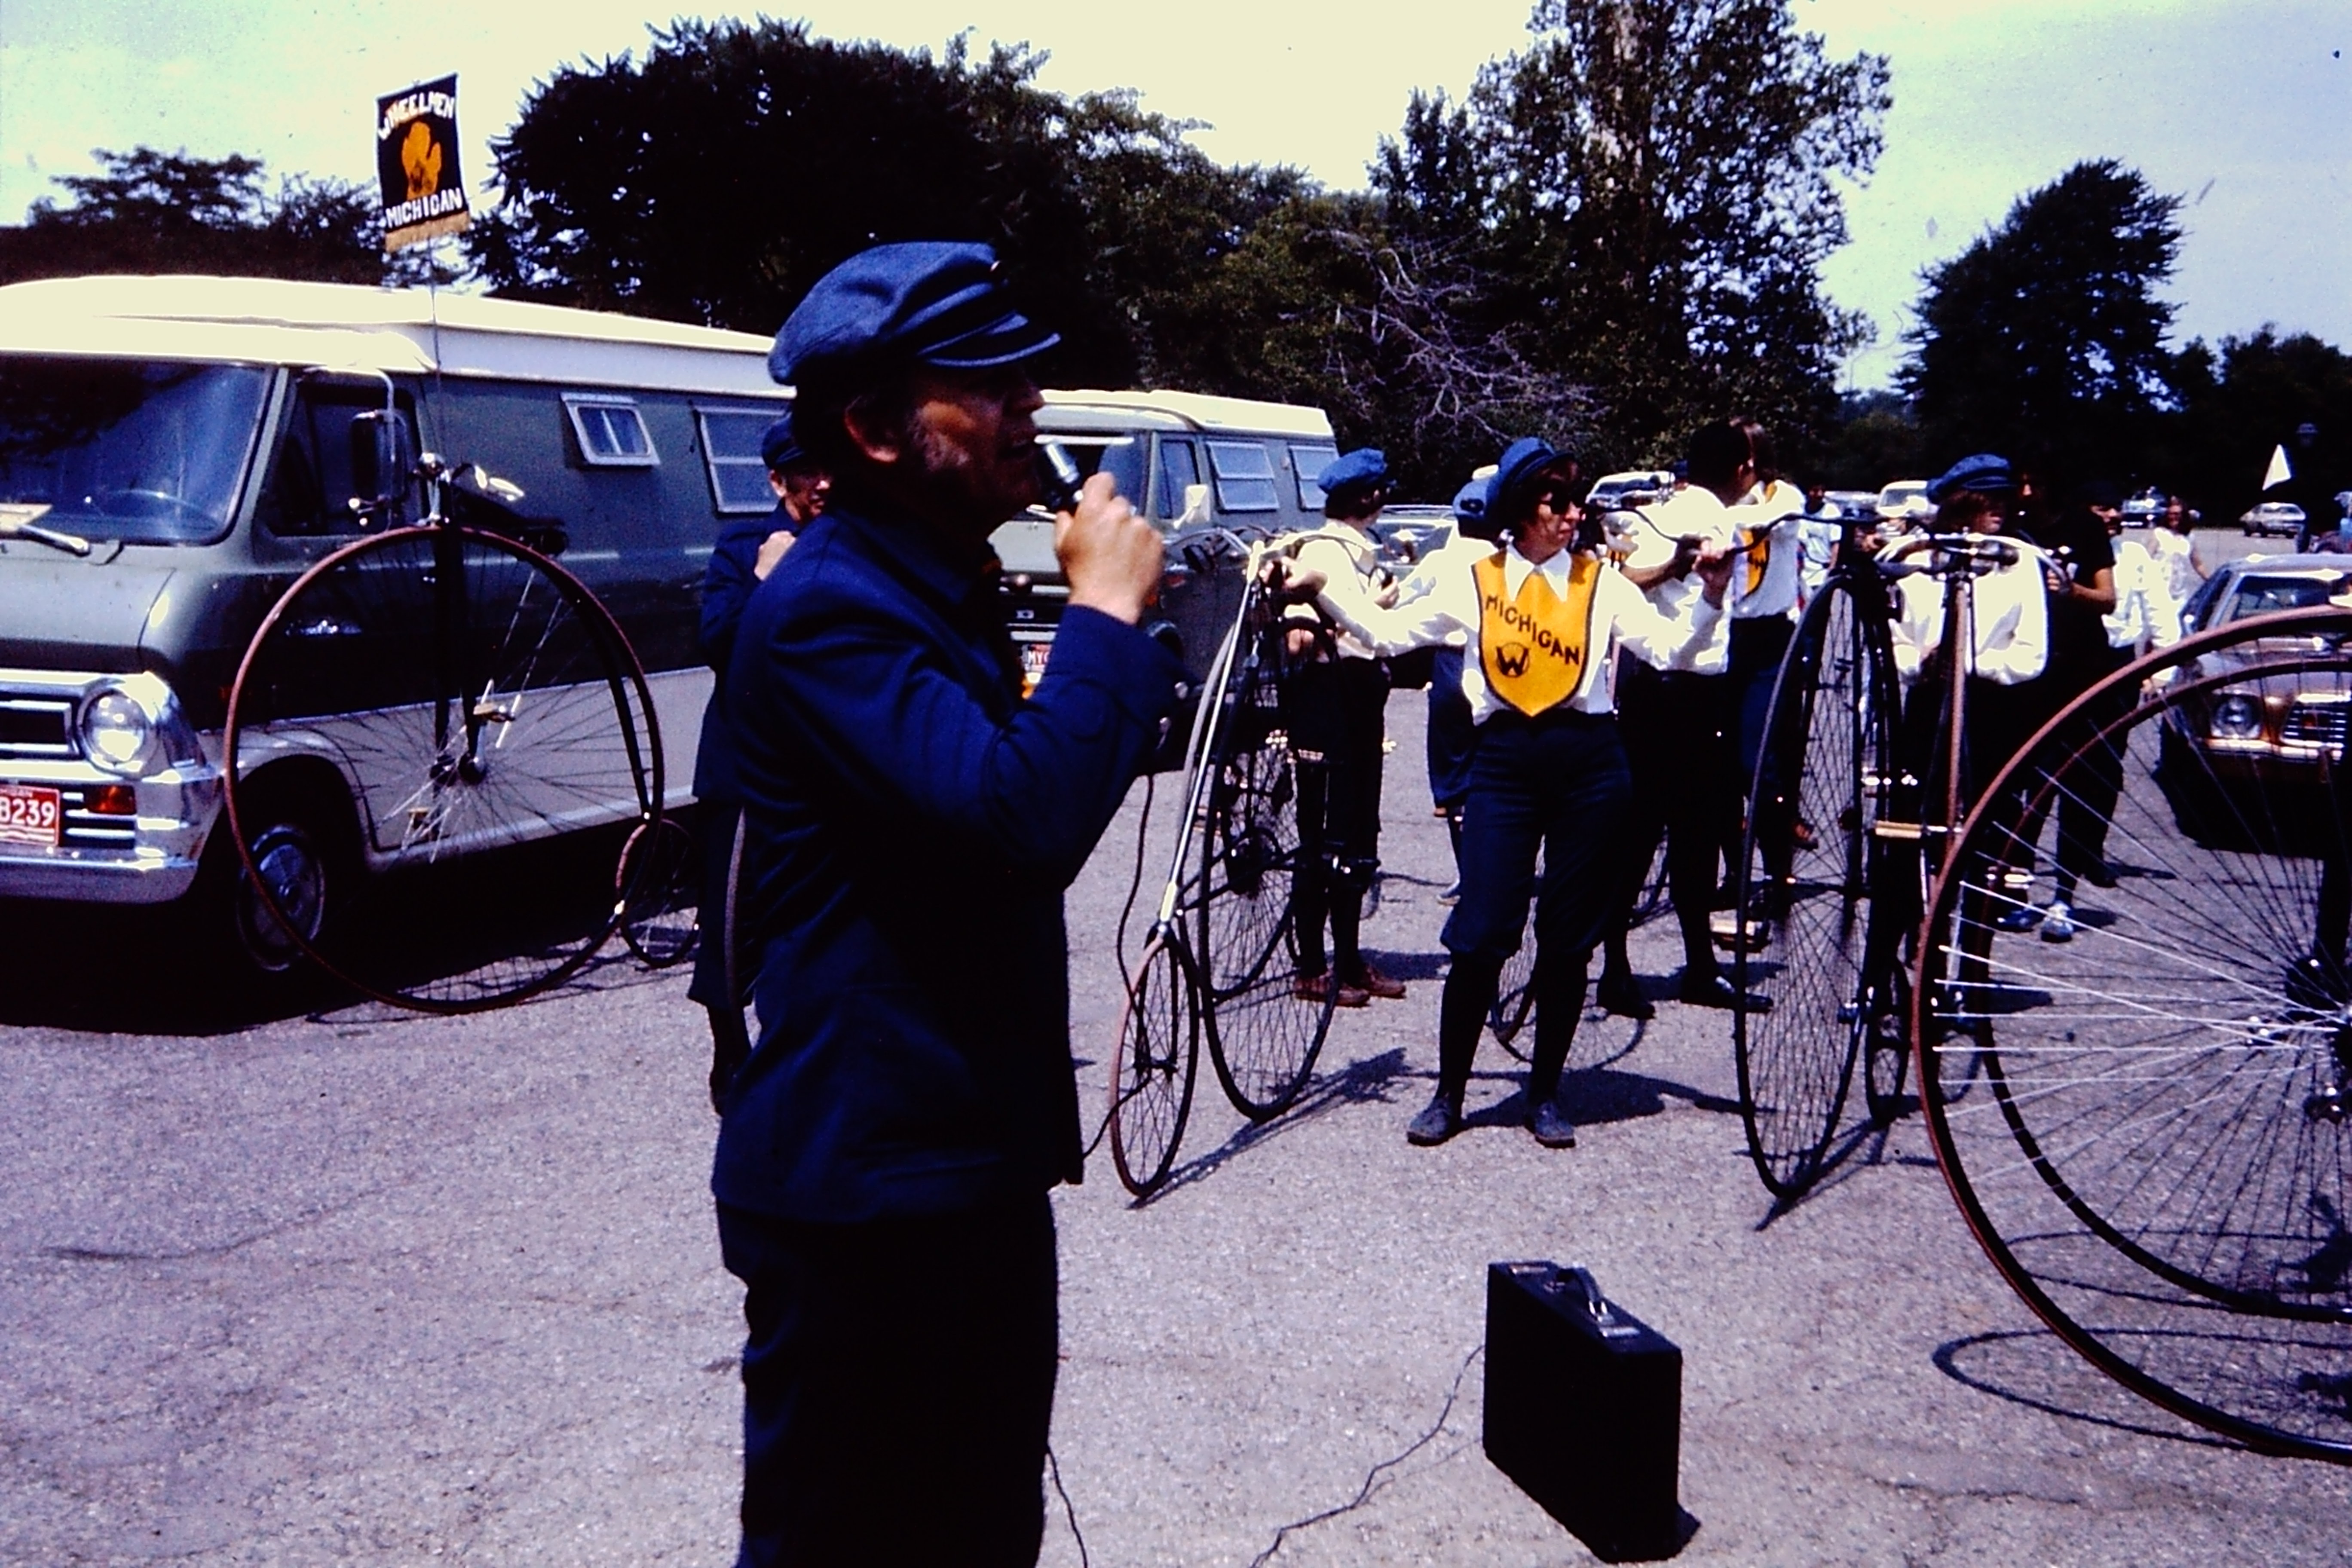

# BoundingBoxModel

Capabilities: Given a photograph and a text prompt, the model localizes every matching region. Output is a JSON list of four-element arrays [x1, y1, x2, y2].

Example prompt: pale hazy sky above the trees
[[0, 0, 2352, 386]]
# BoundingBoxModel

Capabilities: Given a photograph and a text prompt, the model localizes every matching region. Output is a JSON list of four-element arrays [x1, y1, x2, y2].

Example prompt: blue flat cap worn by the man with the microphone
[[767, 240, 1061, 386]]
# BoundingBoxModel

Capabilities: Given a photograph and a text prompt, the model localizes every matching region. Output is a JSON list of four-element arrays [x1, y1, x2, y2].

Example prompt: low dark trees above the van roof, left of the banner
[[0, 146, 390, 285]]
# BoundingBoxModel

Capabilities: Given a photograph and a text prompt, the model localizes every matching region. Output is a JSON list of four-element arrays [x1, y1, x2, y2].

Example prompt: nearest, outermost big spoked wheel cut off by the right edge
[[1917, 611, 2352, 1460]]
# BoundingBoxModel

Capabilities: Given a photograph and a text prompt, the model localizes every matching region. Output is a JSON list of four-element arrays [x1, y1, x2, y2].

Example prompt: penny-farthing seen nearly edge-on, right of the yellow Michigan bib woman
[[1731, 524, 2018, 1199]]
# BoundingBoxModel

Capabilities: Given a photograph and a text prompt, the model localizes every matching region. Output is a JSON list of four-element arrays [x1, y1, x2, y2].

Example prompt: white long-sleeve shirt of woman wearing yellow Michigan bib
[[1317, 548, 1729, 724]]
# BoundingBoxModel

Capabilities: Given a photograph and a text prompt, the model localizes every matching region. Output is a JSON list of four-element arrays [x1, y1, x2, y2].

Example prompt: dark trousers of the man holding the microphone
[[720, 1192, 1061, 1568]]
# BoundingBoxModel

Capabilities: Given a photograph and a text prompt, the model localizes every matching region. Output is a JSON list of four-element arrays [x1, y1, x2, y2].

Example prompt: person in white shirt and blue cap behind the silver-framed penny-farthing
[[1282, 447, 1404, 1006]]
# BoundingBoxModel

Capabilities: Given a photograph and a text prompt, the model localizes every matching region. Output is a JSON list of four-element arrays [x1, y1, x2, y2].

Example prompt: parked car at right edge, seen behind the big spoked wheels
[[2157, 555, 2352, 856]]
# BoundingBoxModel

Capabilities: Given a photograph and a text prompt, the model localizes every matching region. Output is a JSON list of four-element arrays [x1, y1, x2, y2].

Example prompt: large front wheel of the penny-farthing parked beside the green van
[[224, 527, 661, 1013]]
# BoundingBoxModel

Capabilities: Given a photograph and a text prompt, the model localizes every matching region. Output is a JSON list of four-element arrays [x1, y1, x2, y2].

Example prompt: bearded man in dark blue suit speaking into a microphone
[[713, 245, 1181, 1563]]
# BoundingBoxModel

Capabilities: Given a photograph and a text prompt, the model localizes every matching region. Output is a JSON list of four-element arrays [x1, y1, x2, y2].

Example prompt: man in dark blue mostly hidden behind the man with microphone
[[687, 414, 833, 1109]]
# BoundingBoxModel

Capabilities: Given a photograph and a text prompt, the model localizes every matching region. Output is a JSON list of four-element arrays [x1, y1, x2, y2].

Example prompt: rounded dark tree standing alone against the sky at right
[[1900, 157, 2180, 482]]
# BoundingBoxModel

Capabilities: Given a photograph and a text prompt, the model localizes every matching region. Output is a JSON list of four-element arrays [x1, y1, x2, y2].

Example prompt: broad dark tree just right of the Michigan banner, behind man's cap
[[468, 21, 1148, 383]]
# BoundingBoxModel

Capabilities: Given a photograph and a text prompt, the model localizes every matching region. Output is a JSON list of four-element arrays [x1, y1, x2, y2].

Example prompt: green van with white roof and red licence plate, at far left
[[0, 277, 790, 973]]
